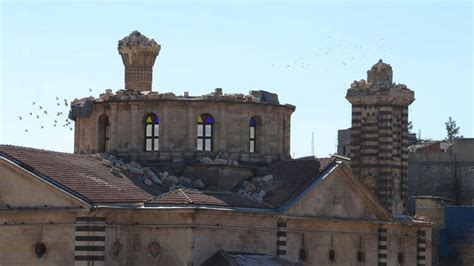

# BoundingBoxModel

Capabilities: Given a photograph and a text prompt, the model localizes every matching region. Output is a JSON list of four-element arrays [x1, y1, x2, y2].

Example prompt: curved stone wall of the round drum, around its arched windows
[[74, 95, 294, 162]]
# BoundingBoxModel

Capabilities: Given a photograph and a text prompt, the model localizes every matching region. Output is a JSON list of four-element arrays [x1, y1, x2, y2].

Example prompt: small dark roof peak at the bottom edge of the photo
[[202, 250, 301, 266]]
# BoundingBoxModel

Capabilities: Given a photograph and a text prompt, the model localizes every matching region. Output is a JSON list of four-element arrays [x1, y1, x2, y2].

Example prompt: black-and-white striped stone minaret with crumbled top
[[346, 60, 415, 214]]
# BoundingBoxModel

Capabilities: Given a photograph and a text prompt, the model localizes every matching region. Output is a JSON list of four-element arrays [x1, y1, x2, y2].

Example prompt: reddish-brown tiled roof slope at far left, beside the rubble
[[0, 145, 153, 203]]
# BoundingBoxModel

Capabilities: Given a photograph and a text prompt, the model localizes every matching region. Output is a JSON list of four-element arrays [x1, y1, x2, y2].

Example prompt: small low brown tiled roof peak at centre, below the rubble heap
[[145, 189, 268, 208]]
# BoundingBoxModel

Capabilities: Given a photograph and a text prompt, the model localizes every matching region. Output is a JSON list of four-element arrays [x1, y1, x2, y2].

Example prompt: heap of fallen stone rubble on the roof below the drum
[[90, 154, 288, 202]]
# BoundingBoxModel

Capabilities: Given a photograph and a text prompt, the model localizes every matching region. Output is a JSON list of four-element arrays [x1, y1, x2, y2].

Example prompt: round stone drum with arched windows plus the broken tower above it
[[70, 32, 295, 162]]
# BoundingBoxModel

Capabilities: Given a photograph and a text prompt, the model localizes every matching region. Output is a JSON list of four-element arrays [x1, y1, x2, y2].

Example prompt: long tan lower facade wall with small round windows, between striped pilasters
[[0, 208, 431, 266]]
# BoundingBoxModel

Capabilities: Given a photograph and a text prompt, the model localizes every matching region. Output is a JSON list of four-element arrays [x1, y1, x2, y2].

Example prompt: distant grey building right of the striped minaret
[[408, 138, 474, 214]]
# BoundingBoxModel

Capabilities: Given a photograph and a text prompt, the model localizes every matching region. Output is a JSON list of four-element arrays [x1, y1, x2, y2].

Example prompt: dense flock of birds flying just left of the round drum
[[18, 89, 92, 133]]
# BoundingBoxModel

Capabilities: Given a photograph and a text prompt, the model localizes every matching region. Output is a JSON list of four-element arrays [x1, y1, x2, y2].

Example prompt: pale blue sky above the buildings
[[0, 1, 474, 157]]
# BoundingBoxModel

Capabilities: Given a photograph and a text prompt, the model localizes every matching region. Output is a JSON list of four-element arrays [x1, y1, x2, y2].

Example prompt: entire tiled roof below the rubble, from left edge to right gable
[[0, 145, 336, 209]]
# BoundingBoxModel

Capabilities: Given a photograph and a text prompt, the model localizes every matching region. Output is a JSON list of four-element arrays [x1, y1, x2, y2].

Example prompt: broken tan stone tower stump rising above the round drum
[[118, 31, 161, 91]]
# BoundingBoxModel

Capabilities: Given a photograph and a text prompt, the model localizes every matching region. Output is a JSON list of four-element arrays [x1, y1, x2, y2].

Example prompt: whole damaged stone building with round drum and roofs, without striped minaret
[[0, 32, 432, 266]]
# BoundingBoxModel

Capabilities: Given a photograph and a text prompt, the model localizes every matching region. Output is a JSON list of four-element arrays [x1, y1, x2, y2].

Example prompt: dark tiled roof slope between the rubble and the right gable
[[257, 158, 335, 208]]
